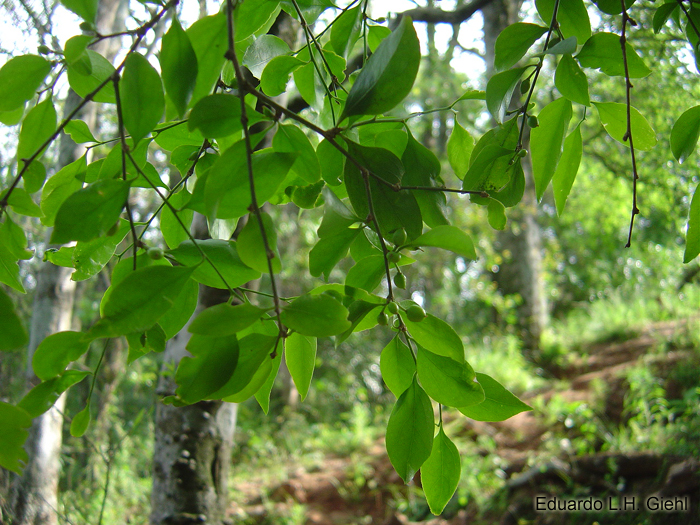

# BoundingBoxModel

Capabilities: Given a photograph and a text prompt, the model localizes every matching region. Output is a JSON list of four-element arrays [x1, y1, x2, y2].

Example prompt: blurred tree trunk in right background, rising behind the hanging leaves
[[482, 0, 548, 354]]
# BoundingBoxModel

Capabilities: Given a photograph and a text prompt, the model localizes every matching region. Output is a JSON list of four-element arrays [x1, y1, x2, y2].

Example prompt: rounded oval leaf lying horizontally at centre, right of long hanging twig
[[282, 294, 350, 337]]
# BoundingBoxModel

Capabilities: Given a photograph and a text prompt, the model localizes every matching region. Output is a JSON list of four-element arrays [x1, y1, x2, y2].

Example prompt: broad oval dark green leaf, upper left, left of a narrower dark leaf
[[119, 53, 165, 144]]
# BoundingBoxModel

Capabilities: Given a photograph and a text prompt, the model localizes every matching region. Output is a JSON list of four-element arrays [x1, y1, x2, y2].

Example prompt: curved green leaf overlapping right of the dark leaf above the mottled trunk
[[215, 333, 277, 403]]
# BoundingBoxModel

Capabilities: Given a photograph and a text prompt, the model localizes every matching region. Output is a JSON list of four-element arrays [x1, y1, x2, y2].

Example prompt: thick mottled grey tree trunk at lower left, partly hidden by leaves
[[151, 214, 238, 525]]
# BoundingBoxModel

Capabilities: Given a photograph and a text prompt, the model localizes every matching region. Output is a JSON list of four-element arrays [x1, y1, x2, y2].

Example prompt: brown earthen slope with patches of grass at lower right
[[224, 317, 700, 525]]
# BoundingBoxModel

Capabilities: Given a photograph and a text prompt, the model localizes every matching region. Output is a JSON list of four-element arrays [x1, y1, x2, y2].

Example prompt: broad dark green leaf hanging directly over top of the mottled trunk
[[175, 334, 240, 403]]
